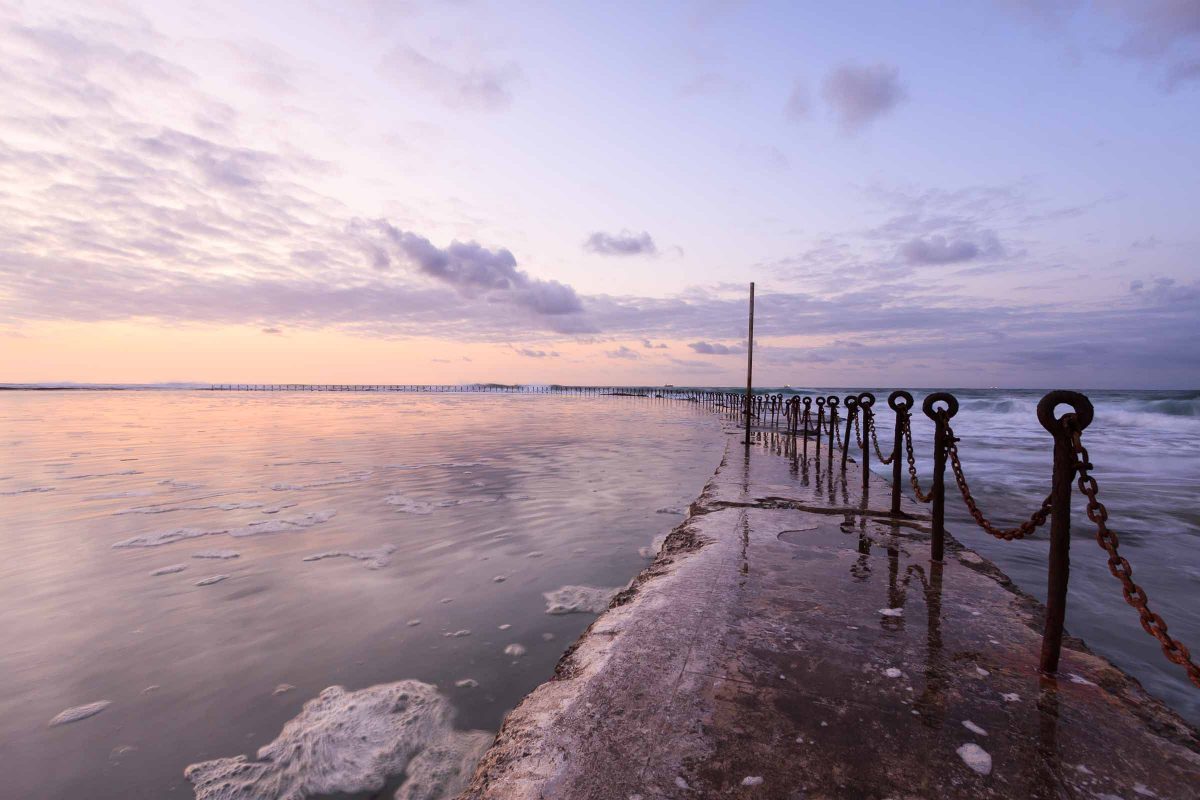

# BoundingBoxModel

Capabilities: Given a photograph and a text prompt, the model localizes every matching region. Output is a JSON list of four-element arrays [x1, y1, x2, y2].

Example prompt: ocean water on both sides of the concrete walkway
[[0, 389, 1200, 799]]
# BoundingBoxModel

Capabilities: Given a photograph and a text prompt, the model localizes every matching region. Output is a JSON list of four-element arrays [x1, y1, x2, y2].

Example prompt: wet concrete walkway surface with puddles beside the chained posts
[[462, 433, 1200, 800]]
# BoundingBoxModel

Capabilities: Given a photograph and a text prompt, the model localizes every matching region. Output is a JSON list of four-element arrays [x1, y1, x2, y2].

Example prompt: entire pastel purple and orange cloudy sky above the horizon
[[0, 0, 1200, 389]]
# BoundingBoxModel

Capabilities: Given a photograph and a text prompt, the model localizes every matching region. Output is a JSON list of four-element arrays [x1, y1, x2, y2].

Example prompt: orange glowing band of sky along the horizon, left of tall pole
[[0, 323, 744, 385]]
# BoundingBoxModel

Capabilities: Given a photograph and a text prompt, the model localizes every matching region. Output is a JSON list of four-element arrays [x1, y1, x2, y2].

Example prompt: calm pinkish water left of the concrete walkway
[[0, 391, 725, 799]]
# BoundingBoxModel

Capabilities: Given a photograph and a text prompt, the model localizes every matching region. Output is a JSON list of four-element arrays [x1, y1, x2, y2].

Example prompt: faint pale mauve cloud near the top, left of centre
[[379, 44, 523, 112]]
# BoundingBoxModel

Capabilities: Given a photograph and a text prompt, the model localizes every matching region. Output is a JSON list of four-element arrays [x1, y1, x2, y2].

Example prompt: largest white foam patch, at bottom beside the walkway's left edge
[[184, 680, 492, 800]]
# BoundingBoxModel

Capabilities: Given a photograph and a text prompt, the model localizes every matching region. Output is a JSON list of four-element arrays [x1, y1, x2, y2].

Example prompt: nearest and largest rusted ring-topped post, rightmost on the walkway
[[1038, 390, 1092, 673]]
